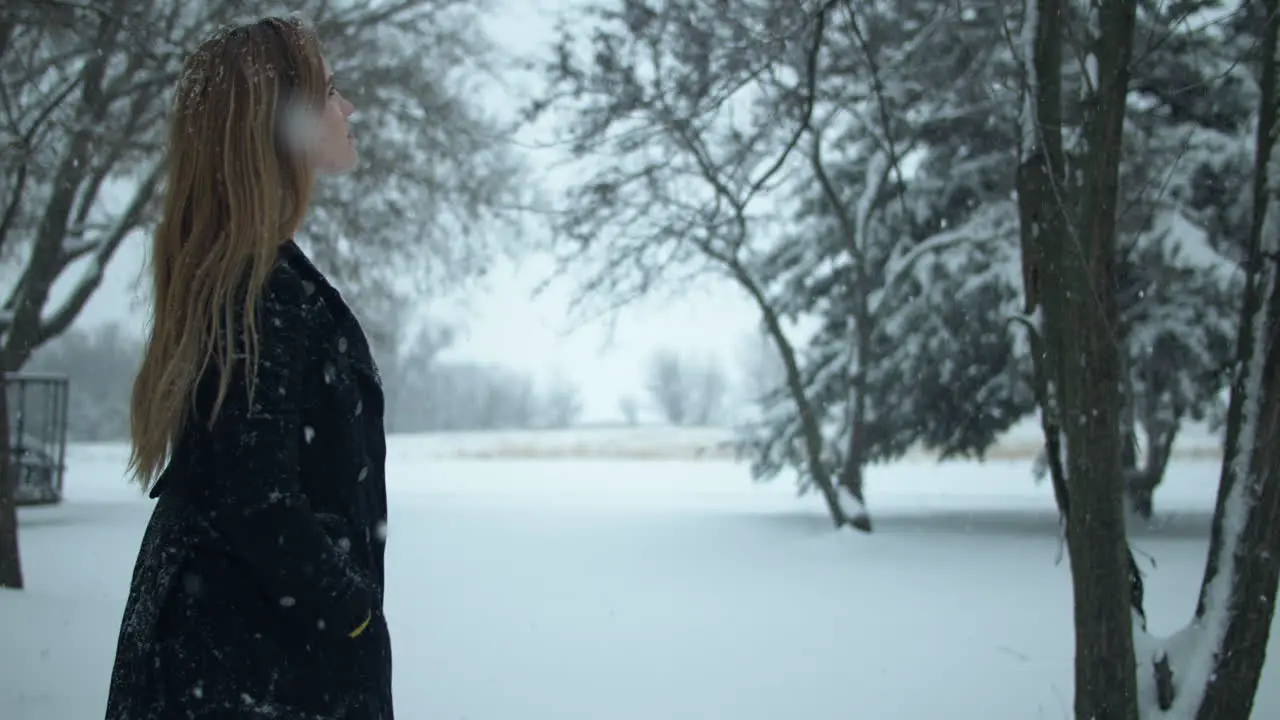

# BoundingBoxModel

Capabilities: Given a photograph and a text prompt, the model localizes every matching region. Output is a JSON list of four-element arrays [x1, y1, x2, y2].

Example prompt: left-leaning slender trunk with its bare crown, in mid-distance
[[531, 0, 869, 529]]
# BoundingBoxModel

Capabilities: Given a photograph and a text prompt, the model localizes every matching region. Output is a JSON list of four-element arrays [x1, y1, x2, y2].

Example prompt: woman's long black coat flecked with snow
[[106, 241, 393, 720]]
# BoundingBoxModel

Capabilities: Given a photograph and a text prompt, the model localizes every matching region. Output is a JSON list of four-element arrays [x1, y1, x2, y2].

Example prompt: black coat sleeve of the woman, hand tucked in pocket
[[200, 266, 372, 639]]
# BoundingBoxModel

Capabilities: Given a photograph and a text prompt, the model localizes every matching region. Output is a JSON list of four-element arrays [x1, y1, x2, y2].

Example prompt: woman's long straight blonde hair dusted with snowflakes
[[129, 18, 328, 487]]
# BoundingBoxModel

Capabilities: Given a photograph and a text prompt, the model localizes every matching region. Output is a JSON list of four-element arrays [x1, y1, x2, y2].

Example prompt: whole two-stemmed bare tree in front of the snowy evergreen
[[527, 0, 1012, 529]]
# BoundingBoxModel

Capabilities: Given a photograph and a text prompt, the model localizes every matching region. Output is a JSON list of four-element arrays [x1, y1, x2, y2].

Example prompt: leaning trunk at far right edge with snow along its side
[[1175, 0, 1280, 720]]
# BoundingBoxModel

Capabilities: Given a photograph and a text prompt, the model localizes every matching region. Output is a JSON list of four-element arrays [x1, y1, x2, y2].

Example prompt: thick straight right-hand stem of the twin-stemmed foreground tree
[[1057, 0, 1138, 720]]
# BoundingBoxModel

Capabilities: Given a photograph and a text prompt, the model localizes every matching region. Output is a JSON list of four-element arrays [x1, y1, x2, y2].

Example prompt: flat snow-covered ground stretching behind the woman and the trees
[[0, 425, 1280, 720]]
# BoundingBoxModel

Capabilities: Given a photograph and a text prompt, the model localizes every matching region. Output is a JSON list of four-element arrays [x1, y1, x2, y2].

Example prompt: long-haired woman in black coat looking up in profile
[[106, 18, 392, 720]]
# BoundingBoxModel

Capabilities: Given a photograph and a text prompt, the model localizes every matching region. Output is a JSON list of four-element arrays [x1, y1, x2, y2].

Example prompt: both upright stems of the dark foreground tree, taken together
[[1018, 0, 1140, 720]]
